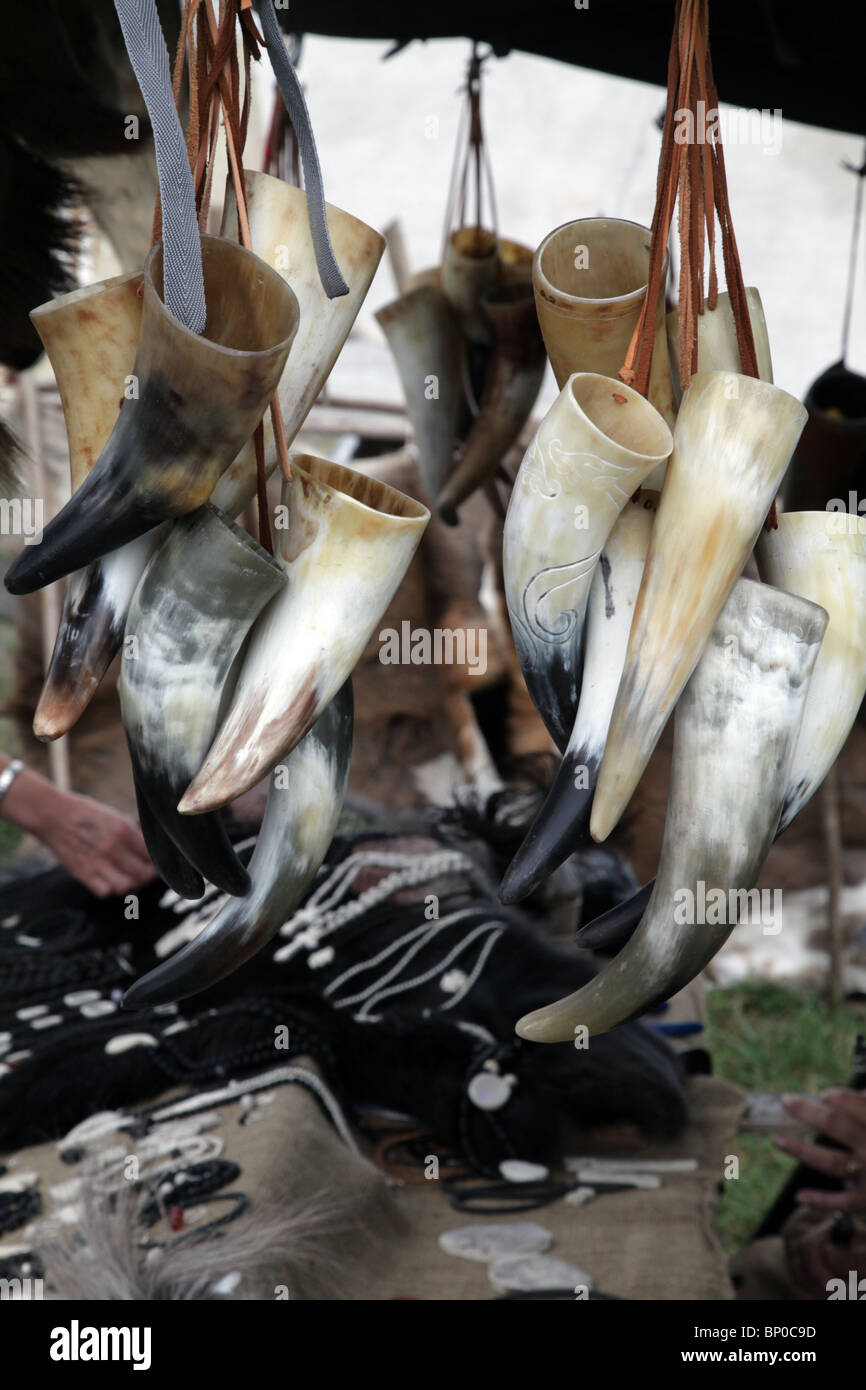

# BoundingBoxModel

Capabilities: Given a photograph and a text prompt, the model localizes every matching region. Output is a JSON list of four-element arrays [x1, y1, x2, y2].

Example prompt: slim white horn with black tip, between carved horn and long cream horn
[[499, 495, 655, 904]]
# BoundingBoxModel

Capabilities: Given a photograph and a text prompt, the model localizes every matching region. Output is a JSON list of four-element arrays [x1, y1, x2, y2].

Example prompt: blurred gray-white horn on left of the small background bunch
[[375, 285, 463, 498]]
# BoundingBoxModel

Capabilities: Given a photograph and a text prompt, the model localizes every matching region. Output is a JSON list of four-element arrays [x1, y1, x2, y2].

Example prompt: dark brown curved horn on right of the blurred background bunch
[[436, 282, 548, 525]]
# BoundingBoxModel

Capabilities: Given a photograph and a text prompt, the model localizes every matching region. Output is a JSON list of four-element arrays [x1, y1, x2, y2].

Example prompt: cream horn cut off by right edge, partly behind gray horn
[[578, 512, 866, 951]]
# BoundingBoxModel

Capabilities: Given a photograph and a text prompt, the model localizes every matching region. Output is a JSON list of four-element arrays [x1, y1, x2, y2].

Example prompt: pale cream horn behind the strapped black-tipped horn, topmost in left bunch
[[211, 170, 385, 517]]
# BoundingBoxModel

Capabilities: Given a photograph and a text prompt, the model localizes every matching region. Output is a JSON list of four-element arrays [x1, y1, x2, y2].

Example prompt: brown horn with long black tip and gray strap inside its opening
[[6, 236, 297, 594]]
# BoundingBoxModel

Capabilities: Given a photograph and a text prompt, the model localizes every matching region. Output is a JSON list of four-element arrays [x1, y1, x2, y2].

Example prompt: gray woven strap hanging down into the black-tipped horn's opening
[[114, 0, 207, 334]]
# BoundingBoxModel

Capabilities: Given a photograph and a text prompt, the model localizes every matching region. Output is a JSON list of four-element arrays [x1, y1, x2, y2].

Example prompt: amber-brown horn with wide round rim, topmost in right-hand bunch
[[532, 217, 676, 425]]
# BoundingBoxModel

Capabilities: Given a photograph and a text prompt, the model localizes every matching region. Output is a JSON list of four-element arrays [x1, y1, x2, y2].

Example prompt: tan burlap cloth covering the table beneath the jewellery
[[0, 1061, 744, 1300]]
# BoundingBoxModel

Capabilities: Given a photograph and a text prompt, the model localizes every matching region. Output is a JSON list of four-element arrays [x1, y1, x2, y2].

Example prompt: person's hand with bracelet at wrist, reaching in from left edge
[[3, 769, 156, 898]]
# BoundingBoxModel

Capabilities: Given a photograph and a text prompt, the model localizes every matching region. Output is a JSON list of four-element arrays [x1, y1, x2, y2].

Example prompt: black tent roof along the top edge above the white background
[[277, 0, 866, 135]]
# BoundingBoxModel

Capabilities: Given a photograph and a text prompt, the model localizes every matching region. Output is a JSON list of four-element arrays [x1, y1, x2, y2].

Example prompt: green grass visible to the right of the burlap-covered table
[[709, 980, 866, 1251]]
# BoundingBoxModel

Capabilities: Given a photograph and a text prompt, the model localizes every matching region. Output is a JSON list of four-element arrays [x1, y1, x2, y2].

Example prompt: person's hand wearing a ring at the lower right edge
[[776, 1088, 866, 1213]]
